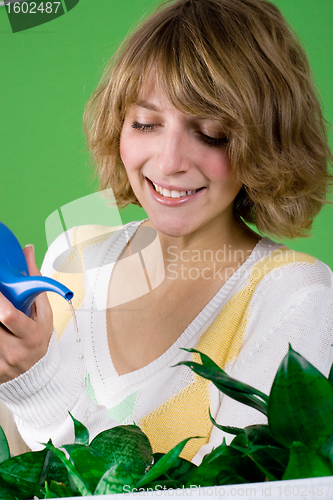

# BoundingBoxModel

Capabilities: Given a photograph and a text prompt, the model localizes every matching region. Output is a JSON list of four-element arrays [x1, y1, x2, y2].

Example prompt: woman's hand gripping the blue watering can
[[0, 246, 53, 383]]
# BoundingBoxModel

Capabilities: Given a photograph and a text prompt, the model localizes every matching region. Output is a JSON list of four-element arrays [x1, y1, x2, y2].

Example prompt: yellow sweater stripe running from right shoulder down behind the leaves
[[139, 247, 316, 460]]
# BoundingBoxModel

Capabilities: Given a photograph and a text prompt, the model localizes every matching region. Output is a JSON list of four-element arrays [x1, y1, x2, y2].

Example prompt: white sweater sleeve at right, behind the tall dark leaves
[[193, 261, 333, 464]]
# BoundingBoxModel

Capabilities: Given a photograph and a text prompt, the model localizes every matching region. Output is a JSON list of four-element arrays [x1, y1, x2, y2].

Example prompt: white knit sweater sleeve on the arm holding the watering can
[[0, 227, 118, 450]]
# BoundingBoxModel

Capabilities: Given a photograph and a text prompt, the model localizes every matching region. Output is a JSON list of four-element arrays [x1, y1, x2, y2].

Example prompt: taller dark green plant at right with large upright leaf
[[176, 347, 333, 486]]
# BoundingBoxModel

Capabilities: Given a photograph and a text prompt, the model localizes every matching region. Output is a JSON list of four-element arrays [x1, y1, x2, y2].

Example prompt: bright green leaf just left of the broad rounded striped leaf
[[62, 444, 107, 491]]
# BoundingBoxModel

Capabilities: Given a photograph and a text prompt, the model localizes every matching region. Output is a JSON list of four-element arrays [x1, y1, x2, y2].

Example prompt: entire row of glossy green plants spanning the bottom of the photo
[[0, 348, 333, 500]]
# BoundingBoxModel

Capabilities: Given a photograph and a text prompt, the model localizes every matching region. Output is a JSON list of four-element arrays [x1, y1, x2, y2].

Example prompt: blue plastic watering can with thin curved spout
[[0, 222, 74, 316]]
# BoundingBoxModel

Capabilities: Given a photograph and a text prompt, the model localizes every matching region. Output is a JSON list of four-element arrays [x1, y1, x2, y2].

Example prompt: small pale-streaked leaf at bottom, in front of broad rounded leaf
[[94, 462, 135, 495]]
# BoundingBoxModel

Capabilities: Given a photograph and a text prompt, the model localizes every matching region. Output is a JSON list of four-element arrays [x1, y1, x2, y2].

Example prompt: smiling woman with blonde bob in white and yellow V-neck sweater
[[0, 0, 333, 463]]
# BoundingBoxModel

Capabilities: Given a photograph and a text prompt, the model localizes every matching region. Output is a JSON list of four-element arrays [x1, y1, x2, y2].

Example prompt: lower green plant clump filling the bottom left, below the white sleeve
[[0, 416, 195, 500]]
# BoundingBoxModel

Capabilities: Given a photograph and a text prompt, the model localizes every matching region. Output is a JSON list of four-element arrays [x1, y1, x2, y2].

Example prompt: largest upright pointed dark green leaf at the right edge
[[268, 348, 333, 450]]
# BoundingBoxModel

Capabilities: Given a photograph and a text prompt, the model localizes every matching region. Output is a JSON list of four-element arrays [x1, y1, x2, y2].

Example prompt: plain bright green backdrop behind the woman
[[0, 0, 333, 268]]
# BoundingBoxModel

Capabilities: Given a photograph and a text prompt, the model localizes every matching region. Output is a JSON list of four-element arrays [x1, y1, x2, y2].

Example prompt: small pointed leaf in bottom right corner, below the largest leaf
[[282, 442, 332, 480]]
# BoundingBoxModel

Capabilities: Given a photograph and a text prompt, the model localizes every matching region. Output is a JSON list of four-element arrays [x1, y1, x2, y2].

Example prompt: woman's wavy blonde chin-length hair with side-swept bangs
[[84, 0, 332, 238]]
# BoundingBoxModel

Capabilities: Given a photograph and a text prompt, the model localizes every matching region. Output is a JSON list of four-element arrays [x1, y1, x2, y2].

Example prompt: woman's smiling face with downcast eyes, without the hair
[[120, 83, 241, 236]]
